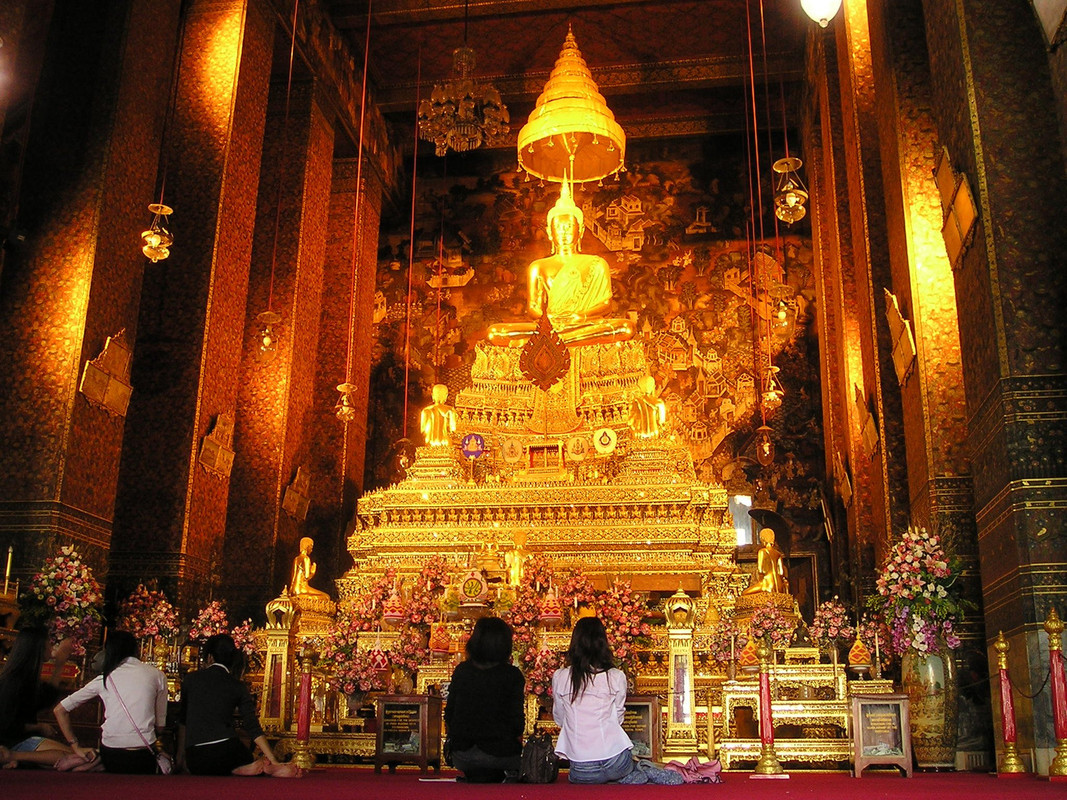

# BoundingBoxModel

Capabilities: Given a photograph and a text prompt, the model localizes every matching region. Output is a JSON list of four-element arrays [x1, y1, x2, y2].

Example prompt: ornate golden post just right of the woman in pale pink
[[664, 588, 711, 755]]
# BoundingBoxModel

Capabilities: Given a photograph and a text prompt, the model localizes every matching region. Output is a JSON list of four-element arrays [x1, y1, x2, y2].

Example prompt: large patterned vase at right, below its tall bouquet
[[901, 641, 959, 769]]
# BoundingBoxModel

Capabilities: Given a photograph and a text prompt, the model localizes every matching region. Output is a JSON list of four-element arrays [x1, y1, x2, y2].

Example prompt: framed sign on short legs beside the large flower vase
[[853, 694, 911, 778]]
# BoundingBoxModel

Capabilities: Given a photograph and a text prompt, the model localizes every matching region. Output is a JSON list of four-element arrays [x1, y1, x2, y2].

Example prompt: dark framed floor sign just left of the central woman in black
[[375, 694, 441, 772]]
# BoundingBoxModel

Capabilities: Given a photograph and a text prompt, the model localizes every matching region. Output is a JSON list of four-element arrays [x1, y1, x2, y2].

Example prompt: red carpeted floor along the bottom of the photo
[[0, 768, 1067, 800]]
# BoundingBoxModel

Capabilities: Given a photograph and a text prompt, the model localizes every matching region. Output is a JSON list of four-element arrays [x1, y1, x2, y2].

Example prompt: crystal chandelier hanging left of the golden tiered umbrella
[[418, 4, 510, 156]]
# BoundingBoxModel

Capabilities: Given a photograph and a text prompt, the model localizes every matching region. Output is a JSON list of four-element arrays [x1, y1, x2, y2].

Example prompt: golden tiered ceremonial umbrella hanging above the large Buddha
[[519, 29, 626, 183]]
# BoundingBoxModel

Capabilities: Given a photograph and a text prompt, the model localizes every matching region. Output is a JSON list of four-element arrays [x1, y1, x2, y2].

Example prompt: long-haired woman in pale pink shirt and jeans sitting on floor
[[552, 617, 683, 785]]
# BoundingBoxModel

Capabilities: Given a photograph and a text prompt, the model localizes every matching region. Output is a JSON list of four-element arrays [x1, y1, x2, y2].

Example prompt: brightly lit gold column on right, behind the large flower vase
[[867, 0, 992, 767]]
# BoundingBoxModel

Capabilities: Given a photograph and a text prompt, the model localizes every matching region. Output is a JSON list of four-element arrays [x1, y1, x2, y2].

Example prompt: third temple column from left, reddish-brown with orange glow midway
[[223, 82, 334, 618]]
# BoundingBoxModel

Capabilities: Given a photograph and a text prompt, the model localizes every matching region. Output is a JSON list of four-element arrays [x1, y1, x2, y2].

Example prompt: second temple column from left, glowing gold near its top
[[111, 0, 273, 607]]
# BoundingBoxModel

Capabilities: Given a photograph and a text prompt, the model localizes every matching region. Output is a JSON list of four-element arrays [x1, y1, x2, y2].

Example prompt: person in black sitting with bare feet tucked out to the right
[[178, 634, 301, 778]]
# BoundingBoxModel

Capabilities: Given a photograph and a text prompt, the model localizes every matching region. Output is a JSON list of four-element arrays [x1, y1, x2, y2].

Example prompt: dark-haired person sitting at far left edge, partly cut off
[[0, 627, 73, 768]]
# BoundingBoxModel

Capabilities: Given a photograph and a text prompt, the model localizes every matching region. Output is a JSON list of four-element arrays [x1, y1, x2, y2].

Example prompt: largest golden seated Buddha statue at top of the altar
[[488, 181, 634, 347]]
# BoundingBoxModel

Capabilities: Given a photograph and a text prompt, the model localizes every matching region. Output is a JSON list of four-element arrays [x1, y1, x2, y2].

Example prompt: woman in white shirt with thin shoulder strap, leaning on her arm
[[55, 630, 166, 774]]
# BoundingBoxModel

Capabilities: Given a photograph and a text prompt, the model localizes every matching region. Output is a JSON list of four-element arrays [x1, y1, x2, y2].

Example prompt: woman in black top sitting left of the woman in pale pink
[[445, 617, 526, 783]]
